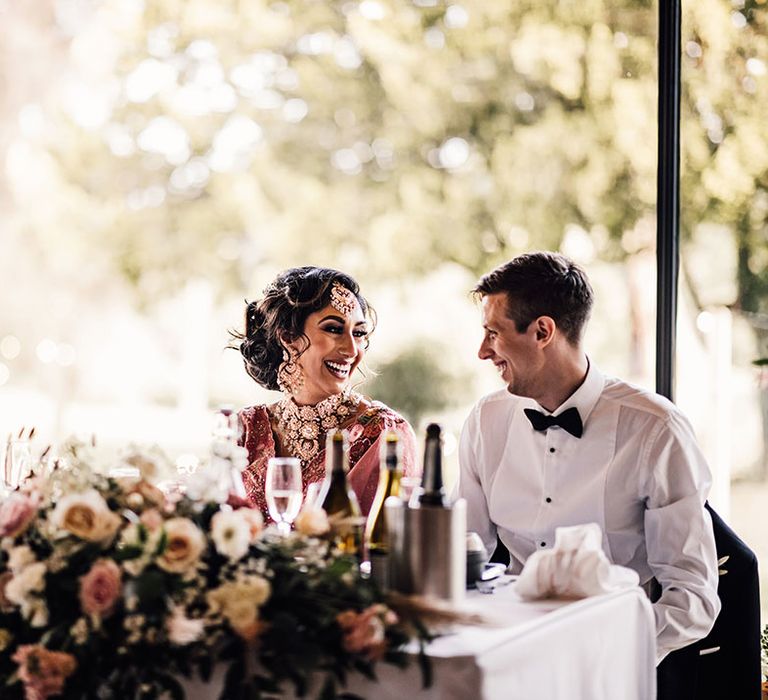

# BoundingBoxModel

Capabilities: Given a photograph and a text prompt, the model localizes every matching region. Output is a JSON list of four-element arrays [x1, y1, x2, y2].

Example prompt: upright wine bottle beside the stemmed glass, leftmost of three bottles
[[318, 429, 363, 557]]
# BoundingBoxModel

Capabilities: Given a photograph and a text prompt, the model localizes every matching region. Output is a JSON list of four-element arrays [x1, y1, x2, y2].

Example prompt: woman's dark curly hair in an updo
[[233, 266, 375, 390]]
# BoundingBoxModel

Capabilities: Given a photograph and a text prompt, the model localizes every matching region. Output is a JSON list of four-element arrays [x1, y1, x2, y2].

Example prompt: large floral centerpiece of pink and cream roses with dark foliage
[[0, 445, 436, 700]]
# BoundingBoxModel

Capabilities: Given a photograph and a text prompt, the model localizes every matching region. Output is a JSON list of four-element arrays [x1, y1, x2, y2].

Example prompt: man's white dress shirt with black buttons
[[456, 364, 720, 661]]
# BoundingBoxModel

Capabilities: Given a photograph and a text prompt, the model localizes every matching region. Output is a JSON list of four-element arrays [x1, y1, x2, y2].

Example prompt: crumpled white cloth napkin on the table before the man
[[515, 523, 640, 600]]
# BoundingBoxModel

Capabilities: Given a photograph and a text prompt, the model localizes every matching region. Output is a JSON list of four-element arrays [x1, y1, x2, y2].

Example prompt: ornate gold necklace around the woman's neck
[[273, 389, 361, 467]]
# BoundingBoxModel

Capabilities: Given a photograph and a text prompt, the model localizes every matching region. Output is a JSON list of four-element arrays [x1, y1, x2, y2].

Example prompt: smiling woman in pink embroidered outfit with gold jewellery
[[235, 267, 416, 515]]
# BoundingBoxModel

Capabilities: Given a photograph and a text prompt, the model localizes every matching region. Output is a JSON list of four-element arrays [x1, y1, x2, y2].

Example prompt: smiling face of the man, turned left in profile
[[477, 293, 542, 396]]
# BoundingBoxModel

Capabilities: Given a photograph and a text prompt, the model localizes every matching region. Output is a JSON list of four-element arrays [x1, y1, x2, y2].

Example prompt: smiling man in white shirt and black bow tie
[[457, 252, 720, 661]]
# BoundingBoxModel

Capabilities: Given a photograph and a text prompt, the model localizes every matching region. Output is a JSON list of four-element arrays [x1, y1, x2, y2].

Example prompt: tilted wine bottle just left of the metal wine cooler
[[365, 432, 403, 588]]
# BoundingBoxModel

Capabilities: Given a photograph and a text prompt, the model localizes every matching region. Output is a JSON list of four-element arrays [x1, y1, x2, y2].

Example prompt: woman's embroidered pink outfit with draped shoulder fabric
[[240, 401, 418, 519]]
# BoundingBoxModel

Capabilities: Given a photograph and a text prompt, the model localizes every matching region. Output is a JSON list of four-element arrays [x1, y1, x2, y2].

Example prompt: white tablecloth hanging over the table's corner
[[186, 586, 656, 700]]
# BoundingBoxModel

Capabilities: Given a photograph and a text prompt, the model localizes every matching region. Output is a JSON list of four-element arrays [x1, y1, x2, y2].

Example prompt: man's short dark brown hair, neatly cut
[[472, 251, 594, 345]]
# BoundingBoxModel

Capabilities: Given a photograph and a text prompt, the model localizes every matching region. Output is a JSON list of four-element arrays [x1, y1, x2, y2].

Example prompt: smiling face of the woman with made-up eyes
[[292, 295, 369, 404]]
